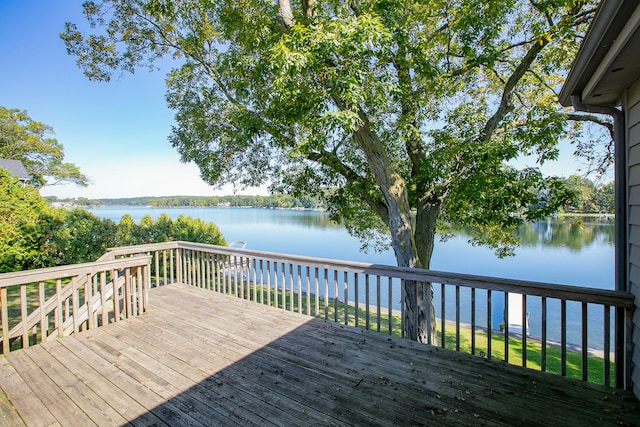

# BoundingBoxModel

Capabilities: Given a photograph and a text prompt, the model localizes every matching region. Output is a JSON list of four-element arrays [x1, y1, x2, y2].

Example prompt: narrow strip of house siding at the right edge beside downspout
[[623, 76, 640, 397]]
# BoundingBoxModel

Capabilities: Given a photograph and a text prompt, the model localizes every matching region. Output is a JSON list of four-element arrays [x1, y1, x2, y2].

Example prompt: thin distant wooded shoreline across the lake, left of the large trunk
[[47, 194, 323, 209]]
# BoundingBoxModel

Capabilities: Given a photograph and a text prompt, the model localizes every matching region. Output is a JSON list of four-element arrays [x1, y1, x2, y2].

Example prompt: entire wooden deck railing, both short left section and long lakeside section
[[0, 242, 634, 388]]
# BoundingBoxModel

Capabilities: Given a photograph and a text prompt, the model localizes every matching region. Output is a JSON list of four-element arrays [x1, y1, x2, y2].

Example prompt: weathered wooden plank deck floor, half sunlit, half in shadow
[[0, 285, 640, 426]]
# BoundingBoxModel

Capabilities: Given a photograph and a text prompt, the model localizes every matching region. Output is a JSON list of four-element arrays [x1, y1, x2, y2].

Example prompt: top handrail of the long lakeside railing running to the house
[[122, 241, 634, 309]]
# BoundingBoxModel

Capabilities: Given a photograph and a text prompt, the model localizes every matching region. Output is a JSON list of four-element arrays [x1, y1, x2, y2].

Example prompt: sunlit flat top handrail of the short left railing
[[0, 255, 151, 288]]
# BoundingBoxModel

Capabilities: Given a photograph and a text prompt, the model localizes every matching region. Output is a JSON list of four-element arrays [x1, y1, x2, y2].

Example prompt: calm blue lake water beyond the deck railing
[[89, 206, 614, 348]]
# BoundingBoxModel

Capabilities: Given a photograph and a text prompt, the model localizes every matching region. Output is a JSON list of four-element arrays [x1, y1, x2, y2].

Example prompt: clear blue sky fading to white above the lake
[[0, 0, 596, 198]]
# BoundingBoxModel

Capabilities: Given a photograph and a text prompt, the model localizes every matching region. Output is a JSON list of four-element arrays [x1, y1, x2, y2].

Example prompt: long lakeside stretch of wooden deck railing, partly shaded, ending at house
[[111, 242, 634, 388]]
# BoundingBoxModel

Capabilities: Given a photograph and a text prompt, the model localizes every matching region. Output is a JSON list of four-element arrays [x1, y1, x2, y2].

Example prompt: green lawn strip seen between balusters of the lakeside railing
[[221, 285, 614, 384]]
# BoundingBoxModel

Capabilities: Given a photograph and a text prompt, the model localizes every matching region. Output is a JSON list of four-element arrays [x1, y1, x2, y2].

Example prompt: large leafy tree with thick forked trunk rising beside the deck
[[62, 0, 596, 340]]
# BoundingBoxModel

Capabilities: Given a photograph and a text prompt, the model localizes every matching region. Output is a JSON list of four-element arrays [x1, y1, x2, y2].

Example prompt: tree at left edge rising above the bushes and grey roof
[[0, 106, 88, 187]]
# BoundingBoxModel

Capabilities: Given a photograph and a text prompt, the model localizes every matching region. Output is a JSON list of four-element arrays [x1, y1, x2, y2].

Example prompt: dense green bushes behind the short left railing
[[0, 168, 226, 273]]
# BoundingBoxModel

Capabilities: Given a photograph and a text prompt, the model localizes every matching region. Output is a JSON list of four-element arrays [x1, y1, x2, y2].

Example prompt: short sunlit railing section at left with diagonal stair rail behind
[[0, 253, 151, 353]]
